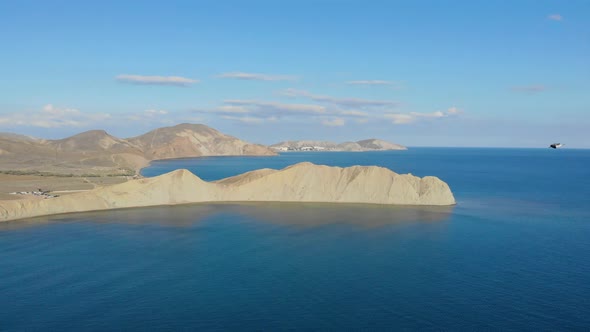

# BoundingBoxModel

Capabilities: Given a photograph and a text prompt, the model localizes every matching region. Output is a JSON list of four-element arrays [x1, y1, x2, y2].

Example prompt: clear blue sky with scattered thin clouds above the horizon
[[0, 0, 590, 148]]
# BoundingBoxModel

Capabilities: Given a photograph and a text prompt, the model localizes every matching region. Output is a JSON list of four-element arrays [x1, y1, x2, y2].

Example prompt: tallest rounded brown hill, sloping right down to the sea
[[128, 123, 276, 160]]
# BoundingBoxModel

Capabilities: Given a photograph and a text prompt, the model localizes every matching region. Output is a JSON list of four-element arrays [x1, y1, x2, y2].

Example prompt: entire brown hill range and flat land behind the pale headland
[[0, 123, 276, 175]]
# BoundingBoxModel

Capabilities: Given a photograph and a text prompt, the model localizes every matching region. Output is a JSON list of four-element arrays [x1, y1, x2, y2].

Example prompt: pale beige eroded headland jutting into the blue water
[[0, 163, 455, 221]]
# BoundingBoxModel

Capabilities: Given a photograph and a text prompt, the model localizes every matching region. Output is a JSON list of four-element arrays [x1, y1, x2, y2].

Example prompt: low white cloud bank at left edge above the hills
[[0, 104, 111, 128]]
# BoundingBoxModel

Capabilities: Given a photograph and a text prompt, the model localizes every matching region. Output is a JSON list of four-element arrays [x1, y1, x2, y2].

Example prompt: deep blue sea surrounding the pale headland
[[0, 148, 590, 331]]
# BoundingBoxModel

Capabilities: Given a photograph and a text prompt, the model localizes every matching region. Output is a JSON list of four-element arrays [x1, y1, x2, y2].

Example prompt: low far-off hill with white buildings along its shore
[[269, 138, 407, 151]]
